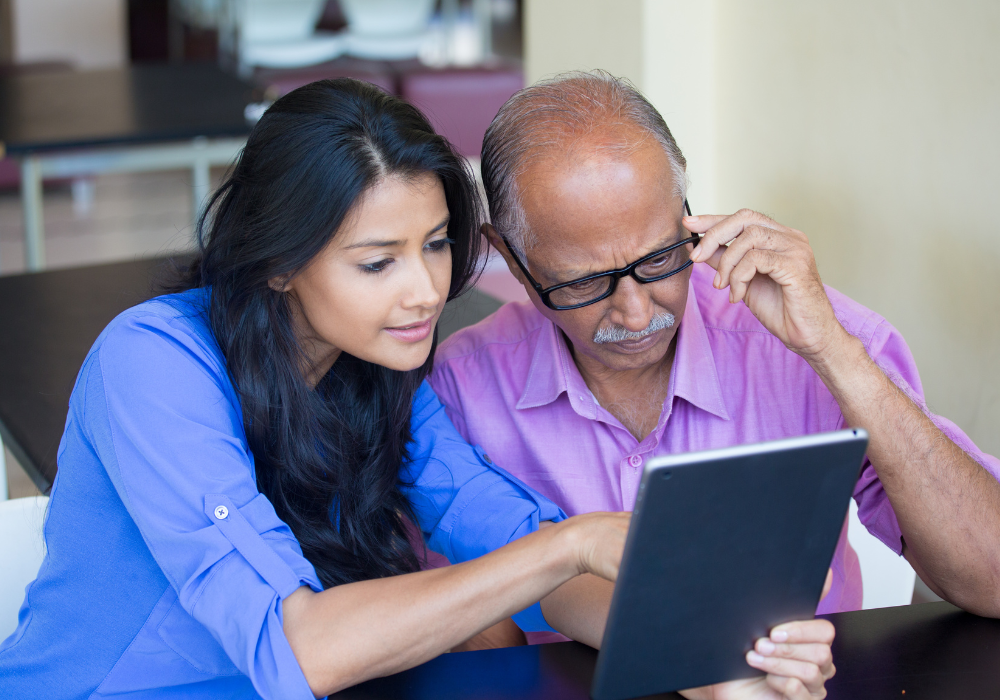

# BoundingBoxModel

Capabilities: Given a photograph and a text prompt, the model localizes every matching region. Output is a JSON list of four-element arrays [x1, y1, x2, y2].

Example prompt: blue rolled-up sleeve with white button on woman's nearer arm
[[85, 315, 322, 700]]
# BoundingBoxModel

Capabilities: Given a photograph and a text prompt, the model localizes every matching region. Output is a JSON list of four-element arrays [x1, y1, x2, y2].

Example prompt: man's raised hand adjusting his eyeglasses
[[684, 209, 847, 360]]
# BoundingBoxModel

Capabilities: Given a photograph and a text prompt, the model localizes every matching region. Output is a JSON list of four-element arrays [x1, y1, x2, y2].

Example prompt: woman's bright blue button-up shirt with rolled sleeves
[[0, 289, 565, 700]]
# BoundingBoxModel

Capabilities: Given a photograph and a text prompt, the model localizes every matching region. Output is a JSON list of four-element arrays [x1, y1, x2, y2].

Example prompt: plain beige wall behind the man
[[525, 0, 1000, 454]]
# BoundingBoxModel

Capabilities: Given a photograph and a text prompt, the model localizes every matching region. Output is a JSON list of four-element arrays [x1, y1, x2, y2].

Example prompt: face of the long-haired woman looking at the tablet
[[282, 174, 451, 385]]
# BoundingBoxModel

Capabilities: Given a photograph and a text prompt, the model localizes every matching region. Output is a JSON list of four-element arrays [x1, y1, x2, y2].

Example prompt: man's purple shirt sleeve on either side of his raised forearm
[[842, 320, 1000, 554]]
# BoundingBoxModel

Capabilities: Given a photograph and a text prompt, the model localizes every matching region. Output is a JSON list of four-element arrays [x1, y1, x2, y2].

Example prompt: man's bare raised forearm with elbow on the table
[[810, 336, 1000, 616]]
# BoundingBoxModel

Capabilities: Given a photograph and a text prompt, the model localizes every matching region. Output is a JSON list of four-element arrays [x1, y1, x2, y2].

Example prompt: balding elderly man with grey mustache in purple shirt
[[431, 74, 1000, 640]]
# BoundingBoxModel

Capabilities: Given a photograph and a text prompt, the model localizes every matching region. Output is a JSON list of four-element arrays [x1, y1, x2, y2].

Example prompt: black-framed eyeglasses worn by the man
[[500, 199, 701, 311]]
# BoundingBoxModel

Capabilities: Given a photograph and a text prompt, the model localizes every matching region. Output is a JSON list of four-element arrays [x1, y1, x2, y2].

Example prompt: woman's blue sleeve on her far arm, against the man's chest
[[402, 382, 566, 632]]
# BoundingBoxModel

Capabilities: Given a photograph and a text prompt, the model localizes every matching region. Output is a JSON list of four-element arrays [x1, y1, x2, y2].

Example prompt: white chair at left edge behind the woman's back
[[0, 496, 49, 640]]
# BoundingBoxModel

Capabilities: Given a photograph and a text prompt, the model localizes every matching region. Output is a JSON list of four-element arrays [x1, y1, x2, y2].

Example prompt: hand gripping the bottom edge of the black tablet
[[681, 620, 836, 700]]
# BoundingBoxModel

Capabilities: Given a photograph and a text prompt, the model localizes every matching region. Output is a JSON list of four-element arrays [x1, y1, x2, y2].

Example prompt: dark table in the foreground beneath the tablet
[[331, 603, 1000, 700]]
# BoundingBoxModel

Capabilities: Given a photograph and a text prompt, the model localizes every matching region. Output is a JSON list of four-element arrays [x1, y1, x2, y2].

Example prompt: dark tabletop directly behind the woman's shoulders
[[0, 258, 500, 492]]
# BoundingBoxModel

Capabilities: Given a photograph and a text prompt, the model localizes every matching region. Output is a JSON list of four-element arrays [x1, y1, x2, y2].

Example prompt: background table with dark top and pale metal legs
[[0, 64, 254, 270]]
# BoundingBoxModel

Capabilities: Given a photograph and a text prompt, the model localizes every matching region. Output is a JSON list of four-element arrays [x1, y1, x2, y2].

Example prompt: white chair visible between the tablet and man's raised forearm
[[847, 498, 917, 610]]
